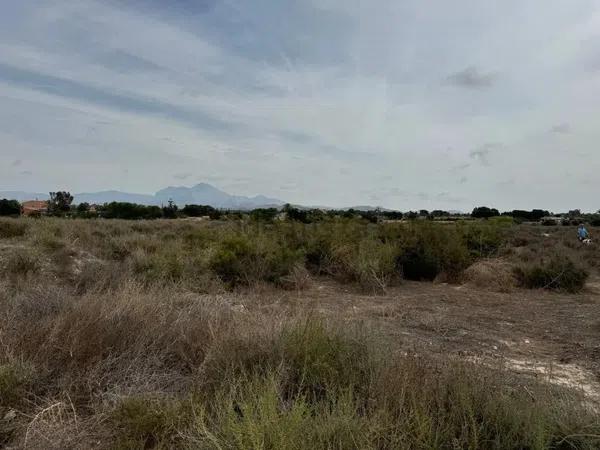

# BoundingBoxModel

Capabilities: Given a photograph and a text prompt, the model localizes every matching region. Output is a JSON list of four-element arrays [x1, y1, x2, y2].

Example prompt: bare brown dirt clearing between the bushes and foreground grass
[[237, 276, 600, 402]]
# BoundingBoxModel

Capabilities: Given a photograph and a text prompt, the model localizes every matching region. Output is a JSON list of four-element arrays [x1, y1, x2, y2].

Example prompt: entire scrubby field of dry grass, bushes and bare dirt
[[0, 218, 600, 449]]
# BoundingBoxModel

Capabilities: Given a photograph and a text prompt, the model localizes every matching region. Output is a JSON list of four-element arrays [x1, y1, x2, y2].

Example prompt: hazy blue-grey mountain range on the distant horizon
[[0, 183, 285, 209]]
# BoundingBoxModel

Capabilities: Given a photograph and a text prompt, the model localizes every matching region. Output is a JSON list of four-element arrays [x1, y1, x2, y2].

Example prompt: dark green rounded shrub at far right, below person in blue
[[515, 256, 589, 293]]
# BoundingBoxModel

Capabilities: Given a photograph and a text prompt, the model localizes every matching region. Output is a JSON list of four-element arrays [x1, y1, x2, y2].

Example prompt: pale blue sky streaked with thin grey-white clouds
[[0, 0, 600, 211]]
